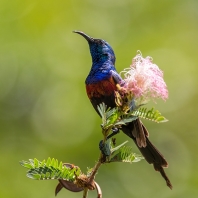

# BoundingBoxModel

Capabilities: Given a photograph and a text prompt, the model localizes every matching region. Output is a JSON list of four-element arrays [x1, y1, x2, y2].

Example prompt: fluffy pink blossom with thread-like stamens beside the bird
[[123, 53, 168, 103]]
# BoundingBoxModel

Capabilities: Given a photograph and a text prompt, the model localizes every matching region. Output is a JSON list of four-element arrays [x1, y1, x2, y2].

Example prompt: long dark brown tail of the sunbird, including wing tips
[[122, 119, 172, 189]]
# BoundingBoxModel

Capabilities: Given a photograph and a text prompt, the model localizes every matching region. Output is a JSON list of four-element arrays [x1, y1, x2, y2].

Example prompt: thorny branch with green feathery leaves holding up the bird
[[20, 103, 142, 198]]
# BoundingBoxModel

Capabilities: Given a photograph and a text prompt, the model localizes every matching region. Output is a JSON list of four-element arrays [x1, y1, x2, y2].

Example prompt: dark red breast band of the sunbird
[[86, 77, 116, 99]]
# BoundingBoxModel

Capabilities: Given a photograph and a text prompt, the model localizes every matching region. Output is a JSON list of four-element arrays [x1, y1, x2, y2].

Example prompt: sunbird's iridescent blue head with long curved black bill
[[74, 31, 115, 64]]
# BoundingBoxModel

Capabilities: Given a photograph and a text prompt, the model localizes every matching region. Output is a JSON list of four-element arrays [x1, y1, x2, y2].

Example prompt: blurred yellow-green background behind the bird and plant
[[0, 0, 198, 198]]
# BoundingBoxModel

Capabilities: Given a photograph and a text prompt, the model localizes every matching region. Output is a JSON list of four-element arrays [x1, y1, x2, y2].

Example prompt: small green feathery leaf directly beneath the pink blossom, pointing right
[[131, 108, 168, 123]]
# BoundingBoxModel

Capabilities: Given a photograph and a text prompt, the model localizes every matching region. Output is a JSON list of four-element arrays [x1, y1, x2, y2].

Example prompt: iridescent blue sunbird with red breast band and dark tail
[[73, 30, 172, 189]]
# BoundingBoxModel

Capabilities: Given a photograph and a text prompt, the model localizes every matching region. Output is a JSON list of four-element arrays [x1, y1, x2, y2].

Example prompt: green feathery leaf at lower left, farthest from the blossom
[[20, 158, 81, 182]]
